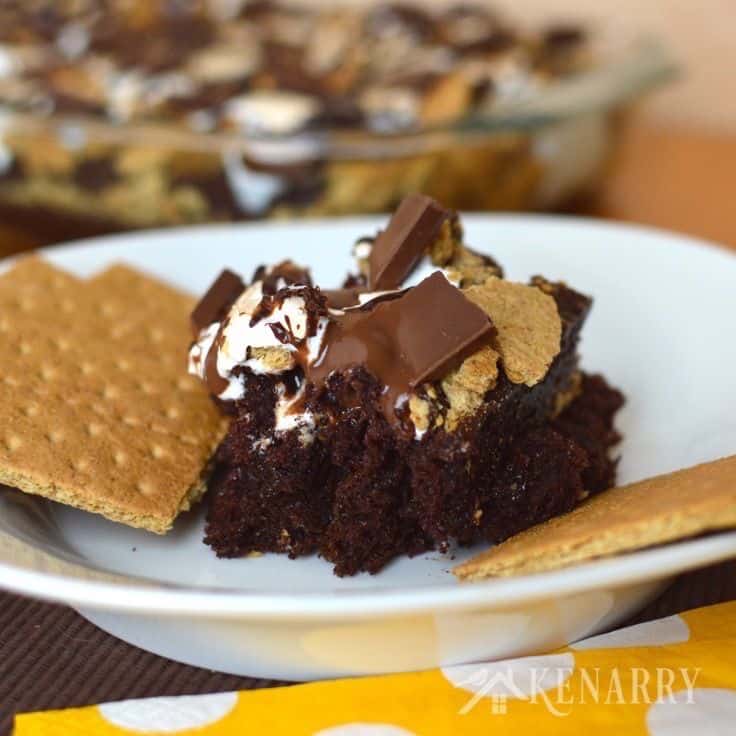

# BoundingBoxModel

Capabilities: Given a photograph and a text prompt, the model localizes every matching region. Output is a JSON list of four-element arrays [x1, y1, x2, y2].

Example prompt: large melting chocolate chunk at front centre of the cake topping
[[307, 272, 495, 421]]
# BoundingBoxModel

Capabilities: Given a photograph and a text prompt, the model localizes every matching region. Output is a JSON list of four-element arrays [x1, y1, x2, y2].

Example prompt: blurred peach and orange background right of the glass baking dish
[[312, 0, 736, 249]]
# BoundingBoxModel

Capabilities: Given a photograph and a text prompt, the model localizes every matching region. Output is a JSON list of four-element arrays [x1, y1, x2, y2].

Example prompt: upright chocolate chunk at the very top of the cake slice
[[369, 194, 452, 291]]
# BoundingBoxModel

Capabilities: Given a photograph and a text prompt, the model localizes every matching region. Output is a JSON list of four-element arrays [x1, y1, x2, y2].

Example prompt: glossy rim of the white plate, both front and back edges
[[0, 213, 736, 620]]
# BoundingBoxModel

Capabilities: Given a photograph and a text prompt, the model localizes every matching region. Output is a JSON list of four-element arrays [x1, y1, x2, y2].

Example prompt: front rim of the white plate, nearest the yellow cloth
[[0, 532, 736, 620]]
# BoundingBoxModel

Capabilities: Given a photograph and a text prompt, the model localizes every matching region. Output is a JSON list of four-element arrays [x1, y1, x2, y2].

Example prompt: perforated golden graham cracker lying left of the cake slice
[[0, 258, 225, 534]]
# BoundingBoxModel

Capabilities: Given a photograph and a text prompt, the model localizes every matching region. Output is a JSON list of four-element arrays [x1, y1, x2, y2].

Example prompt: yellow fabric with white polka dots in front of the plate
[[15, 602, 736, 736]]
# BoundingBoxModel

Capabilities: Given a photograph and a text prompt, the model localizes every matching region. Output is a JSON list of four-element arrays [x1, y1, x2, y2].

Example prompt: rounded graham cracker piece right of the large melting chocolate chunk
[[463, 277, 562, 386]]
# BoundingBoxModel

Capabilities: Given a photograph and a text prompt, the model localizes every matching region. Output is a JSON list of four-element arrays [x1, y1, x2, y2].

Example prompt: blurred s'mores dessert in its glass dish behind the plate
[[0, 0, 674, 244]]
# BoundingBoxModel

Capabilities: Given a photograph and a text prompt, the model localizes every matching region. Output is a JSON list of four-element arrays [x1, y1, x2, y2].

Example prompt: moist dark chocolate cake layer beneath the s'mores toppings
[[205, 285, 623, 575]]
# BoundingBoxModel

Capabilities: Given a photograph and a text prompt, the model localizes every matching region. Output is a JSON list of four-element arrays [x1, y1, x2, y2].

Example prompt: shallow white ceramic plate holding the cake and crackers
[[0, 216, 736, 679]]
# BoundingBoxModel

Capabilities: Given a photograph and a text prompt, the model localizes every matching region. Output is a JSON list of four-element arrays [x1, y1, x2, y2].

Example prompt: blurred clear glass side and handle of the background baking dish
[[0, 23, 674, 244]]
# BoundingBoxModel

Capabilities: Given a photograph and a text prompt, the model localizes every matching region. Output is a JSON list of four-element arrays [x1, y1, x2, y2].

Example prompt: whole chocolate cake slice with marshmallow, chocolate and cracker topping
[[190, 195, 623, 575]]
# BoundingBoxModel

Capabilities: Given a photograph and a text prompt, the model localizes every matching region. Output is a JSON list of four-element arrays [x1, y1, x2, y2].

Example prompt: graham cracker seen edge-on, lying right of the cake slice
[[453, 455, 736, 580]]
